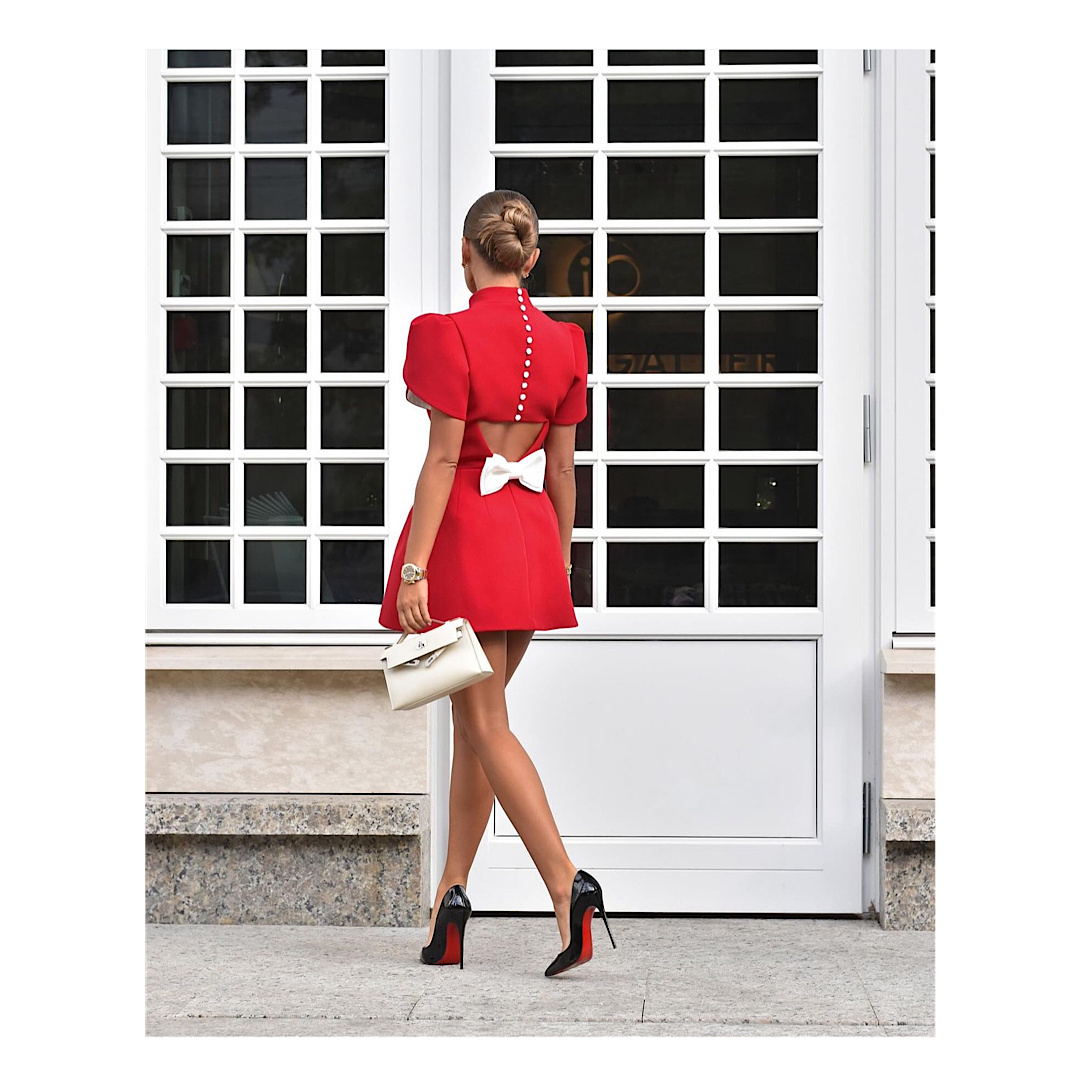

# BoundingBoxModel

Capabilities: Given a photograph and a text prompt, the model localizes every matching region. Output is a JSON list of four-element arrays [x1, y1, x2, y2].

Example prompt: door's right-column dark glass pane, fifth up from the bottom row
[[720, 232, 818, 296]]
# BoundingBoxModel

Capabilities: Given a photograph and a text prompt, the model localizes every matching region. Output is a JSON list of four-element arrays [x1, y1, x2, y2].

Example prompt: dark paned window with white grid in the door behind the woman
[[486, 50, 828, 632]]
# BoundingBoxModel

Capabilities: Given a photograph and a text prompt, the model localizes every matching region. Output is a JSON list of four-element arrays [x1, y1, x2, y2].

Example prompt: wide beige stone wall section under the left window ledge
[[146, 671, 429, 794]]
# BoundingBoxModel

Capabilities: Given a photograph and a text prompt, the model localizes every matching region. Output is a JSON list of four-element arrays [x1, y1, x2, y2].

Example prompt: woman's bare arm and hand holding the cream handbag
[[397, 408, 465, 634]]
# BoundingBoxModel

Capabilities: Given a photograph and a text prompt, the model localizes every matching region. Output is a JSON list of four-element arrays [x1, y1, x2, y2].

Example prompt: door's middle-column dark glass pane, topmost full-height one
[[608, 79, 705, 143]]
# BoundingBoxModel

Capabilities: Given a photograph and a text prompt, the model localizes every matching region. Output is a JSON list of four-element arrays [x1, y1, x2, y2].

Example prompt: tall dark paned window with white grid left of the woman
[[146, 44, 419, 631]]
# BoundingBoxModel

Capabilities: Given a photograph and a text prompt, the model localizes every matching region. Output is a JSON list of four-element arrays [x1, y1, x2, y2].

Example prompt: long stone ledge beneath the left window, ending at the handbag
[[144, 645, 386, 672]]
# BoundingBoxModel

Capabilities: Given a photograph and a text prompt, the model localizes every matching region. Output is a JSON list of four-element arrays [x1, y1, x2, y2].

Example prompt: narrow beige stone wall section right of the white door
[[881, 675, 937, 799]]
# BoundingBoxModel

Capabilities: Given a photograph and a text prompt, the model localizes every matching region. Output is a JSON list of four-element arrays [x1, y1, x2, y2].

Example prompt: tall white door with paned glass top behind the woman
[[441, 49, 873, 913]]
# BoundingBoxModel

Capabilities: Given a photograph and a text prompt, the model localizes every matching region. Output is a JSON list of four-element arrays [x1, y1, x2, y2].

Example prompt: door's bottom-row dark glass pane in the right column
[[720, 543, 818, 607]]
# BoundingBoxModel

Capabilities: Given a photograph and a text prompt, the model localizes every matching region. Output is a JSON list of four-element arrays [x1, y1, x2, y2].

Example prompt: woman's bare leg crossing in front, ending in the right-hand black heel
[[450, 631, 577, 948]]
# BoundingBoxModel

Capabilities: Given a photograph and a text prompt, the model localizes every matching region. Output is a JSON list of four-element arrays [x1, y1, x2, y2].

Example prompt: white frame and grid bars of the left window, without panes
[[145, 42, 433, 640]]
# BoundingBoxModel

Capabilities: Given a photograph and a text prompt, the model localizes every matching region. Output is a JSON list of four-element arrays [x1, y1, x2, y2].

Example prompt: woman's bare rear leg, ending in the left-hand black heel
[[428, 630, 532, 944]]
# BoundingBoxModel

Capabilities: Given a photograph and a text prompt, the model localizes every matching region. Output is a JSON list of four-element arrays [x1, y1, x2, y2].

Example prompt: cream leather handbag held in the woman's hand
[[381, 619, 495, 710]]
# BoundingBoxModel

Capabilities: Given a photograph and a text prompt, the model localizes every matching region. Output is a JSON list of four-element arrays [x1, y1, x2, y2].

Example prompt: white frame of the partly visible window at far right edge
[[882, 49, 937, 635]]
